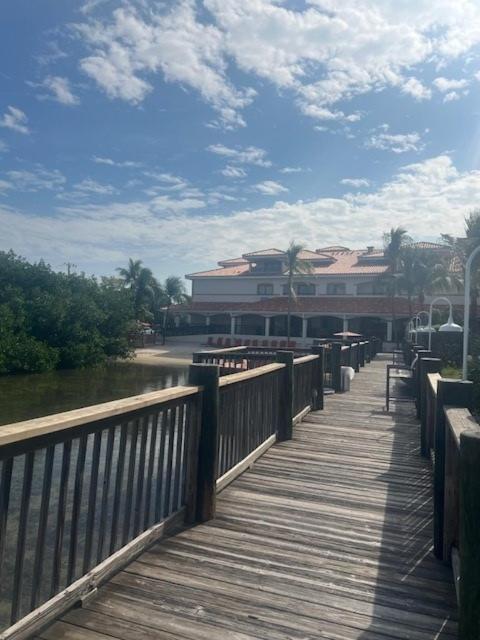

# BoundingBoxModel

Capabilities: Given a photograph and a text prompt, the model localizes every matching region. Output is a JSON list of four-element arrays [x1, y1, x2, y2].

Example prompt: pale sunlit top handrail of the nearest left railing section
[[0, 386, 201, 447]]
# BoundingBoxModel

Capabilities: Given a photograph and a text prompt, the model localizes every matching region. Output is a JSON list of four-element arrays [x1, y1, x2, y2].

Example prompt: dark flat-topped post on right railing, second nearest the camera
[[433, 379, 473, 560]]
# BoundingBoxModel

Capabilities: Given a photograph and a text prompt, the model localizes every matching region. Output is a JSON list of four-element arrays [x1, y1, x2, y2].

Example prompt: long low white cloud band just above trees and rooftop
[[0, 155, 480, 275]]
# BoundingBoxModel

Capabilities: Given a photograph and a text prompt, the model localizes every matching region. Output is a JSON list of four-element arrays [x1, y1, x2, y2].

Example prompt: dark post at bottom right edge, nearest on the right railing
[[459, 430, 480, 640]]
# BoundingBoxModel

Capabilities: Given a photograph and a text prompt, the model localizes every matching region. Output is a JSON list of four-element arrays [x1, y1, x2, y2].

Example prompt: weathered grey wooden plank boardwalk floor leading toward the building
[[39, 357, 457, 640]]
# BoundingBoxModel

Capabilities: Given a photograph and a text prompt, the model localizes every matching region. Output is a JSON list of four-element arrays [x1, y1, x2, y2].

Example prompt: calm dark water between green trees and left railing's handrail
[[0, 362, 187, 425]]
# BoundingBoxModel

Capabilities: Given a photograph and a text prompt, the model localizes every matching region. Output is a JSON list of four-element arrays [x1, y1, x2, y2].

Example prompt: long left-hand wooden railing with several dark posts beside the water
[[0, 338, 378, 640]]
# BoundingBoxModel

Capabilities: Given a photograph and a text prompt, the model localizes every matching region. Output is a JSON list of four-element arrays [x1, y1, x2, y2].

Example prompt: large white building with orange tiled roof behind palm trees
[[176, 243, 461, 343]]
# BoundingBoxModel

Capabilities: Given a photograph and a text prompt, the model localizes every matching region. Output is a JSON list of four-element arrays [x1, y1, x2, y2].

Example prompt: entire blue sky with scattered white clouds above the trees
[[0, 0, 480, 277]]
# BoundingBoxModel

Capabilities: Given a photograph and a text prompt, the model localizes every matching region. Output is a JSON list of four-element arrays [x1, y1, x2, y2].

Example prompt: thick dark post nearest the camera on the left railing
[[188, 364, 219, 522]]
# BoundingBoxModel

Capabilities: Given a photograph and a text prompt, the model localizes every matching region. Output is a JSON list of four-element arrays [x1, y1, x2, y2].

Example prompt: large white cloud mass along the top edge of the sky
[[71, 0, 480, 127]]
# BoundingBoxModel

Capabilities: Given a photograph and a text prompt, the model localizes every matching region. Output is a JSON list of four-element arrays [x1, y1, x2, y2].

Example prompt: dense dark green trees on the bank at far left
[[0, 252, 134, 374]]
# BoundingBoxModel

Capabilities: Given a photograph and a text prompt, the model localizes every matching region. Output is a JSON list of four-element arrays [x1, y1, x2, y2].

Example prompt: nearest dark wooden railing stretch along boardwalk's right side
[[416, 362, 480, 640]]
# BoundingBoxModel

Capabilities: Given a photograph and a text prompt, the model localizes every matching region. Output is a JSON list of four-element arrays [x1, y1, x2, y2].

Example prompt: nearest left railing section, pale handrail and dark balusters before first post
[[0, 387, 201, 638]]
